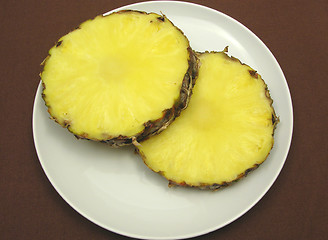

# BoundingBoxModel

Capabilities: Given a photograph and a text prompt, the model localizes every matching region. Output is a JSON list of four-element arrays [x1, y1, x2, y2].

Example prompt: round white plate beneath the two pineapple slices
[[33, 1, 293, 239]]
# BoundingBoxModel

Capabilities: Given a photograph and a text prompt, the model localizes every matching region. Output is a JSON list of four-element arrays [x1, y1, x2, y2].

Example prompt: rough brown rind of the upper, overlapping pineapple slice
[[40, 10, 199, 147]]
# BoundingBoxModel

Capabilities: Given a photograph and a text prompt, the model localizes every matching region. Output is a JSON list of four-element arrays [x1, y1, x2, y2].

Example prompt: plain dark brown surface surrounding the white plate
[[0, 0, 328, 240]]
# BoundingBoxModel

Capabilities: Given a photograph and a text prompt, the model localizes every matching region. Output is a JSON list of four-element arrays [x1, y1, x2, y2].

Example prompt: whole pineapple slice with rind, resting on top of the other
[[40, 10, 197, 146]]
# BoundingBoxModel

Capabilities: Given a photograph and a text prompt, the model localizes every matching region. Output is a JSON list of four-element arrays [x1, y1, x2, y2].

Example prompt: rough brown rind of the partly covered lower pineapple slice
[[135, 49, 280, 191]]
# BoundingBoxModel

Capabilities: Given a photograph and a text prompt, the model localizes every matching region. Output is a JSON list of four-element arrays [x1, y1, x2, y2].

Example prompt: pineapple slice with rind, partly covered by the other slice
[[136, 49, 278, 190]]
